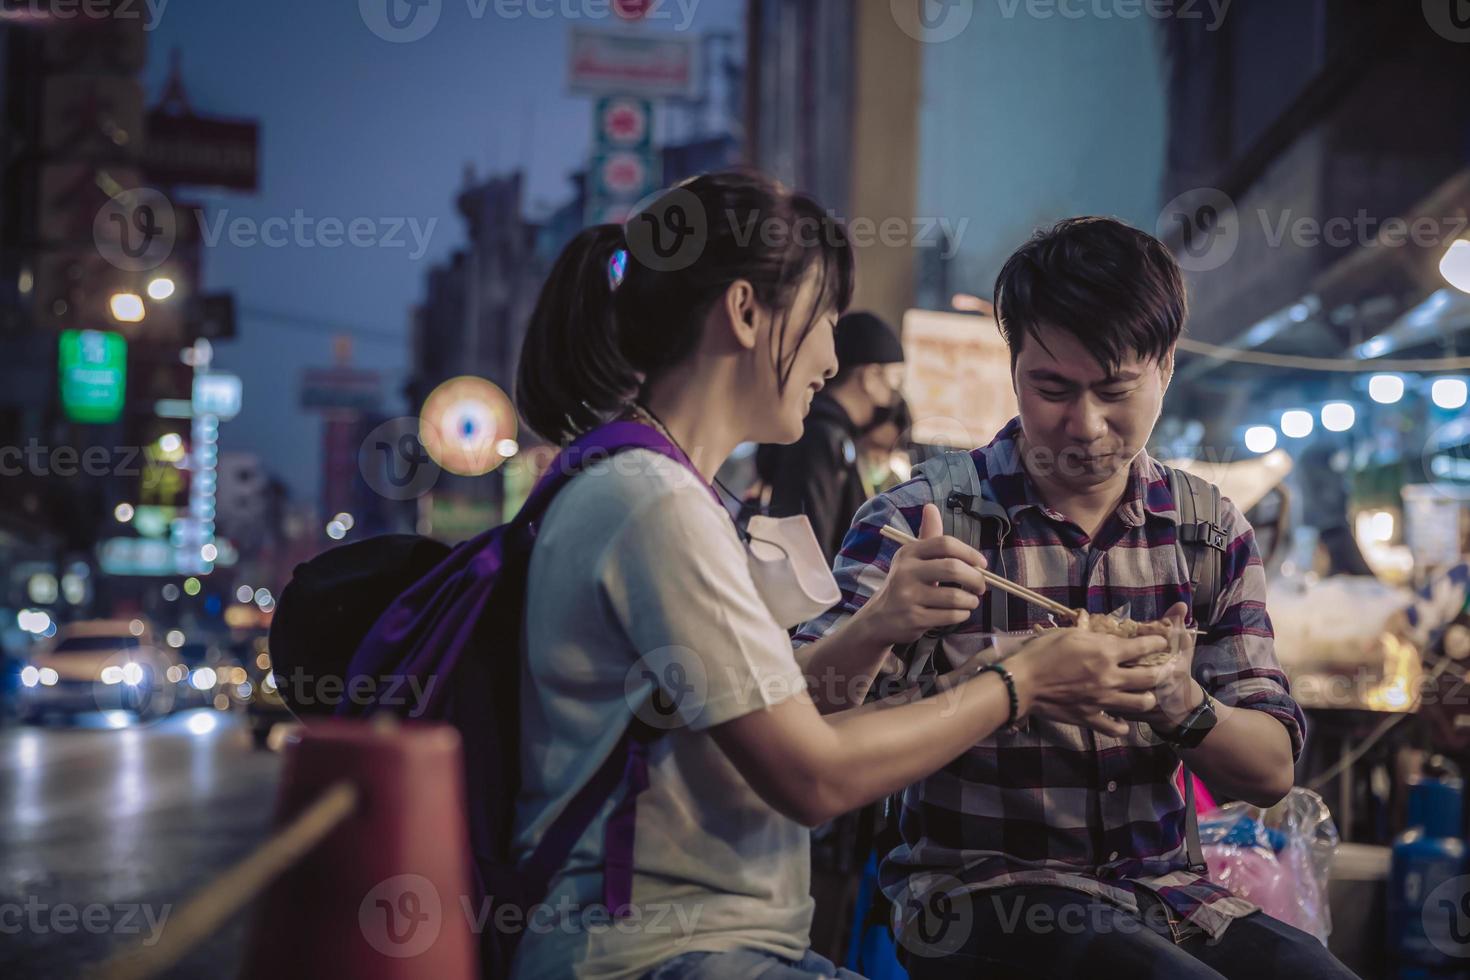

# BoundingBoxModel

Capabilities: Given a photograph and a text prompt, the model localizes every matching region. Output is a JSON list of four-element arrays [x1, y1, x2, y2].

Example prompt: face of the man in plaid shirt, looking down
[[1011, 326, 1173, 492]]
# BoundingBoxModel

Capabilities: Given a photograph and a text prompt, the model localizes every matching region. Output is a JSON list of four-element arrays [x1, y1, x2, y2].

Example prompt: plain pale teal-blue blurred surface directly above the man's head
[[914, 3, 1167, 310]]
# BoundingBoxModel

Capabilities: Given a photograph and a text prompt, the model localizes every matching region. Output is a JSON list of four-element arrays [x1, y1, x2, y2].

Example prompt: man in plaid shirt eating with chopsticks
[[795, 219, 1352, 980]]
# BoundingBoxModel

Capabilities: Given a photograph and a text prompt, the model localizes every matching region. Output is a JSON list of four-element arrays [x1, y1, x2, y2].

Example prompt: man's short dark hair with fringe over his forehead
[[995, 217, 1188, 370]]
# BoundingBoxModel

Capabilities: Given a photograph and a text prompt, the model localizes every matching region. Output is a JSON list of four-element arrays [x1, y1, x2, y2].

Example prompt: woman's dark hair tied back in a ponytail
[[516, 172, 854, 444]]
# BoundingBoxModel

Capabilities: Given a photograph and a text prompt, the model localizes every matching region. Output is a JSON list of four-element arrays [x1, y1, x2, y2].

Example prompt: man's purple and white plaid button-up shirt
[[795, 419, 1305, 939]]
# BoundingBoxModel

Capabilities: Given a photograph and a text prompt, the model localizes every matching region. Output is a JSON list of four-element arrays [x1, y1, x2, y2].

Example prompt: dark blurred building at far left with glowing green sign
[[0, 11, 254, 637]]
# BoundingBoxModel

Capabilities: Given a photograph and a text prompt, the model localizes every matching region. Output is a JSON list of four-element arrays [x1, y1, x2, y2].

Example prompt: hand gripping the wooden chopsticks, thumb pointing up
[[853, 504, 986, 646]]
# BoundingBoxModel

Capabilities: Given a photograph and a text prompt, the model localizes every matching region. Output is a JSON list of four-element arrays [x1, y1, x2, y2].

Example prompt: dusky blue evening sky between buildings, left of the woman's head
[[140, 0, 744, 500]]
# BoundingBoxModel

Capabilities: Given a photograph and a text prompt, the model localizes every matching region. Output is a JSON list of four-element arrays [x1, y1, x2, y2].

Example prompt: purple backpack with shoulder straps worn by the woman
[[337, 422, 717, 977]]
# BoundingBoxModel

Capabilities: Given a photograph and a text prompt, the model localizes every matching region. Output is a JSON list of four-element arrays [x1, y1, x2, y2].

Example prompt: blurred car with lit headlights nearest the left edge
[[21, 620, 184, 721]]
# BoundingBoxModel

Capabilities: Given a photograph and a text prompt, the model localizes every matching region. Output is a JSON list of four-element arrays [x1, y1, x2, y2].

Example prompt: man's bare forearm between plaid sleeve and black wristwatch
[[1179, 687, 1295, 807]]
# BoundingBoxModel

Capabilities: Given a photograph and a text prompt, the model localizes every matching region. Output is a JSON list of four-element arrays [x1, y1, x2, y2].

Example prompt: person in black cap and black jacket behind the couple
[[756, 313, 904, 563]]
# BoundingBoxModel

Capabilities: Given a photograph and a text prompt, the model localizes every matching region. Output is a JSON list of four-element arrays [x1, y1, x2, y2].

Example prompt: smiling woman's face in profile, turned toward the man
[[748, 267, 836, 444]]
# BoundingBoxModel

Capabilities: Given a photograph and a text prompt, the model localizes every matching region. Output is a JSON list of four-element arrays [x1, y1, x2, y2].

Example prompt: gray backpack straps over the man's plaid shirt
[[908, 451, 1229, 873]]
